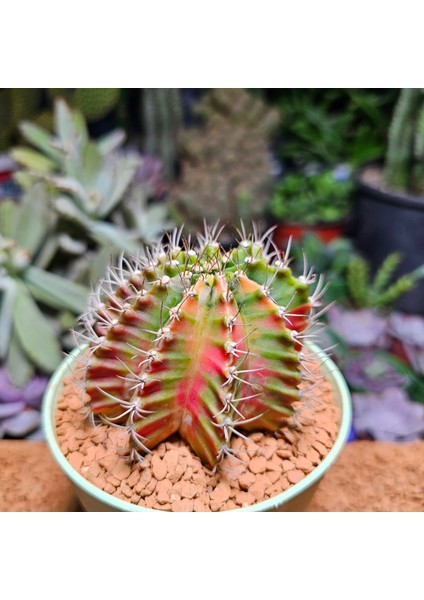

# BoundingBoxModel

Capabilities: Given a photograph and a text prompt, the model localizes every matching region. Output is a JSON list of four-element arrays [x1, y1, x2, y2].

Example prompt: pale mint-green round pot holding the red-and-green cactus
[[42, 344, 352, 512]]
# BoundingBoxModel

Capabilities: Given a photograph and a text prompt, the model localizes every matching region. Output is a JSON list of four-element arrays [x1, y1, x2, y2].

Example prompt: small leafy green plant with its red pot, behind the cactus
[[269, 167, 352, 247]]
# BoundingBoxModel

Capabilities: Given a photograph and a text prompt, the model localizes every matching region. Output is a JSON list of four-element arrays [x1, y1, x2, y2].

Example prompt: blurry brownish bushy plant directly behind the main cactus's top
[[171, 88, 279, 239]]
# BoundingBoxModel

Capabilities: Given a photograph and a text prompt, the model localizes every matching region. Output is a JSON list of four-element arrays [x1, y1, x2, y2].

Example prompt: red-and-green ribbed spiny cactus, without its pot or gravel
[[80, 227, 324, 467]]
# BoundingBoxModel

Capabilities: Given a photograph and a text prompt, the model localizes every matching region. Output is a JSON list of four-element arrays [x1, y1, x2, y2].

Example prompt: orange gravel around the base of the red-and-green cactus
[[56, 366, 340, 512]]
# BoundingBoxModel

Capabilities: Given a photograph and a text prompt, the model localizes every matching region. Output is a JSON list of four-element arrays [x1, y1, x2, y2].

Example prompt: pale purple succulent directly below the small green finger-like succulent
[[328, 306, 388, 348]]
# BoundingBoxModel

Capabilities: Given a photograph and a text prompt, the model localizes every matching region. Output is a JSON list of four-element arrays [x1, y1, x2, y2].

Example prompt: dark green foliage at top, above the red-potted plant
[[268, 88, 396, 167]]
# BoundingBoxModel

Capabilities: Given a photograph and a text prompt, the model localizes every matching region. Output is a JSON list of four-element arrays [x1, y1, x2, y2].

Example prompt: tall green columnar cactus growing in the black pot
[[385, 88, 424, 194]]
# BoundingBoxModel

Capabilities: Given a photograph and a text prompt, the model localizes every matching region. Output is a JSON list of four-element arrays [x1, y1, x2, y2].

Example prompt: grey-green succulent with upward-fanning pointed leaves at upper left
[[11, 99, 141, 252]]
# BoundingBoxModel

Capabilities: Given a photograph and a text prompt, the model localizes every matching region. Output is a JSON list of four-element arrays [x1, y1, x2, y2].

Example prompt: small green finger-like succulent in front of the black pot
[[347, 252, 424, 309]]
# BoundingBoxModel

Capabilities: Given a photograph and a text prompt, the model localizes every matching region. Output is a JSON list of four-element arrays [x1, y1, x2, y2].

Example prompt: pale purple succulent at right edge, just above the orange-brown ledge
[[352, 387, 424, 442]]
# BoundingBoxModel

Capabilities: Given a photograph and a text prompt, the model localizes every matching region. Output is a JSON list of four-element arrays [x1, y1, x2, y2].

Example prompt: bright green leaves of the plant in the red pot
[[270, 171, 352, 225]]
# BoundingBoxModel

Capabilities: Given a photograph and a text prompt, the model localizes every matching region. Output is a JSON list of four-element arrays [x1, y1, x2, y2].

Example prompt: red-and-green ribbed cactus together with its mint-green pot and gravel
[[43, 228, 351, 511]]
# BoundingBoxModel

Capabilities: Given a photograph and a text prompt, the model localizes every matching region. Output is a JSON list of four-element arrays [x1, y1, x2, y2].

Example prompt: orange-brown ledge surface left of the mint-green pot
[[0, 440, 78, 512]]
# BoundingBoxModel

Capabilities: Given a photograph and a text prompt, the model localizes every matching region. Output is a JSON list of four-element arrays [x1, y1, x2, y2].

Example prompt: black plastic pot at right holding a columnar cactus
[[355, 167, 424, 314]]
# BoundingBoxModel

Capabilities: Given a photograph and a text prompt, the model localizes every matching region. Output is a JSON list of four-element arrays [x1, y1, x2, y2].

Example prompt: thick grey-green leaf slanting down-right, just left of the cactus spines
[[25, 267, 89, 313]]
